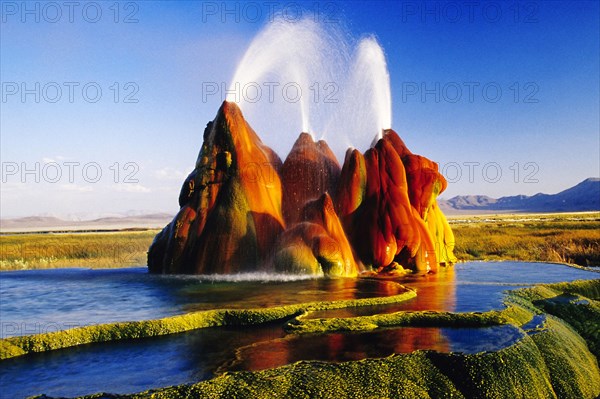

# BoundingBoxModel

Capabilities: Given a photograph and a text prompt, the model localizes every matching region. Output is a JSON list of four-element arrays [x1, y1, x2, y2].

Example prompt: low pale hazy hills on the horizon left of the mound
[[0, 213, 173, 233]]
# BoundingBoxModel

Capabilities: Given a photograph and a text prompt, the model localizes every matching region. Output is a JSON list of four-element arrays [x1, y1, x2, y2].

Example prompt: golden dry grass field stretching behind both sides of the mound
[[0, 212, 600, 271]]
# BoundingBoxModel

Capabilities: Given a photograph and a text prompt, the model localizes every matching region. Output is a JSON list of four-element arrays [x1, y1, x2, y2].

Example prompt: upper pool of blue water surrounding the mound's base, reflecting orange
[[0, 262, 600, 336]]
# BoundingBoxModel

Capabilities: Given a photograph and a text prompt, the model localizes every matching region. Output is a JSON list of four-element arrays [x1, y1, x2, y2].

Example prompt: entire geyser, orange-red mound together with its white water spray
[[148, 20, 455, 276]]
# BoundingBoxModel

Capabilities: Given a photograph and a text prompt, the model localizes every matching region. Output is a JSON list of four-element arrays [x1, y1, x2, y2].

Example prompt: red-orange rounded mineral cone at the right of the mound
[[336, 130, 454, 271]]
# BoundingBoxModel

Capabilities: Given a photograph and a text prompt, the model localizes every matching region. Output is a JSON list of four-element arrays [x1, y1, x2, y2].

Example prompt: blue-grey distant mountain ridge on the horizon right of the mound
[[439, 177, 600, 214]]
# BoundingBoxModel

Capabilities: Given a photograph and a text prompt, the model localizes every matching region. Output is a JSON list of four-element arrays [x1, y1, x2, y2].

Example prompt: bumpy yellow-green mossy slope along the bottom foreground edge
[[49, 312, 600, 399]]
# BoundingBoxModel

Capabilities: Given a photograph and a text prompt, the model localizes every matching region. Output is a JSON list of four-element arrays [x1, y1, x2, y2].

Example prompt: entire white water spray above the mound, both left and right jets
[[227, 18, 392, 159]]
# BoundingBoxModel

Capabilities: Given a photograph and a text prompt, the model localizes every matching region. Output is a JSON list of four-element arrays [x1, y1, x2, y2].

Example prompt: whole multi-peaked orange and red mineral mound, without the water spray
[[148, 102, 455, 276]]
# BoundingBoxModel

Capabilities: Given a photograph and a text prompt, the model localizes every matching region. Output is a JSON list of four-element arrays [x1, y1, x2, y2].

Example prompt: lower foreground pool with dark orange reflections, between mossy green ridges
[[0, 324, 522, 398]]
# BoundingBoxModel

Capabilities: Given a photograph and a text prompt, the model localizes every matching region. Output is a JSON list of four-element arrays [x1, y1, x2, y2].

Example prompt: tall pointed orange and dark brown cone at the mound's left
[[148, 102, 285, 274]]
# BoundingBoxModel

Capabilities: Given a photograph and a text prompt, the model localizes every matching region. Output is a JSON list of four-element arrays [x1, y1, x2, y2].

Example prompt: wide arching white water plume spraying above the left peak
[[227, 19, 347, 142]]
